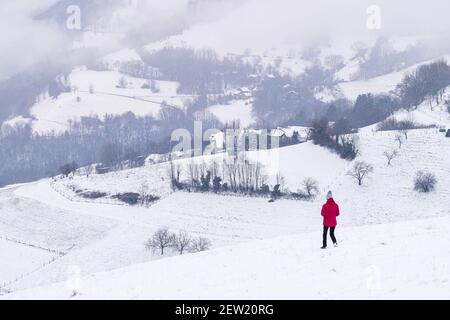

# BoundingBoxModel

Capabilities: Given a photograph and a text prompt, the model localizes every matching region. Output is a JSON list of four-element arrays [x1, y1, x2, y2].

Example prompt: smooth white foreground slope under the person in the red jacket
[[6, 217, 450, 299]]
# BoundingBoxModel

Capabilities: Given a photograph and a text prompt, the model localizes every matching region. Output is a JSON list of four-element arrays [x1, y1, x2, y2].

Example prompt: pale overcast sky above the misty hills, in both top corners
[[0, 0, 450, 78]]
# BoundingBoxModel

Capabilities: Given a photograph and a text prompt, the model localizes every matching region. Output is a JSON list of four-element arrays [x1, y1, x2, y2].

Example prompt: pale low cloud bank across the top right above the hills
[[178, 0, 450, 51]]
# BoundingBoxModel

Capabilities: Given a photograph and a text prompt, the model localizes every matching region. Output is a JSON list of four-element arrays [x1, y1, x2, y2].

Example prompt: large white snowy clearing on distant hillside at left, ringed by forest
[[30, 68, 188, 133]]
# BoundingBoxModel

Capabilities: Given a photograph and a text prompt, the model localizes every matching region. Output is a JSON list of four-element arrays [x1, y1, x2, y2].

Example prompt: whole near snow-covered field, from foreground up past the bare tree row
[[0, 104, 450, 299]]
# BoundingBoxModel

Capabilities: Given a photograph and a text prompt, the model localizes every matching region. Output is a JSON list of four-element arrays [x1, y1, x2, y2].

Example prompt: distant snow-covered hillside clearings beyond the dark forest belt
[[10, 27, 450, 133]]
